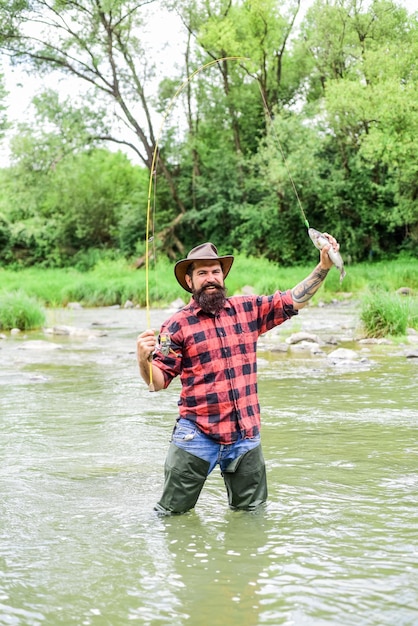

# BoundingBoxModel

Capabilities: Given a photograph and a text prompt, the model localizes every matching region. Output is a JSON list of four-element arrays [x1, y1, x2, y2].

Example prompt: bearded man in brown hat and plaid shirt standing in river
[[137, 238, 339, 515]]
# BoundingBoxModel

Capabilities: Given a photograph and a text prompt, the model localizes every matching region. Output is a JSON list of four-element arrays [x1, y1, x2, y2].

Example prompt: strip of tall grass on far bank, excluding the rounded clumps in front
[[0, 255, 418, 307]]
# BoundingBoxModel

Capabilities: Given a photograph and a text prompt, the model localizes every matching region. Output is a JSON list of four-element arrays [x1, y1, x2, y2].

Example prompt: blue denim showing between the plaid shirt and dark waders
[[172, 418, 260, 474]]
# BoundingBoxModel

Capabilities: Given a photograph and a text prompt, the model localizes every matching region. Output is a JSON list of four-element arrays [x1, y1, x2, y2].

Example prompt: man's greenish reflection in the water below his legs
[[147, 508, 271, 626]]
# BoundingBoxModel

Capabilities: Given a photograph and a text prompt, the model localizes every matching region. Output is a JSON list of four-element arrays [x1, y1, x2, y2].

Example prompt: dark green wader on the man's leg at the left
[[154, 443, 209, 515]]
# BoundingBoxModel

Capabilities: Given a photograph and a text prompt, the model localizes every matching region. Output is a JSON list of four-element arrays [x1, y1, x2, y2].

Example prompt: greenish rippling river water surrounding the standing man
[[0, 305, 418, 626]]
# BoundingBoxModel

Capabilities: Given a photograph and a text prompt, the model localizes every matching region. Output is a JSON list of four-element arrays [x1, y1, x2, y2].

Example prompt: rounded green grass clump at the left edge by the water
[[0, 291, 45, 330]]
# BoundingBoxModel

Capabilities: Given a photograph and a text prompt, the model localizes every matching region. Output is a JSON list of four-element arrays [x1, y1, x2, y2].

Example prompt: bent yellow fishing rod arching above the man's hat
[[145, 56, 248, 390]]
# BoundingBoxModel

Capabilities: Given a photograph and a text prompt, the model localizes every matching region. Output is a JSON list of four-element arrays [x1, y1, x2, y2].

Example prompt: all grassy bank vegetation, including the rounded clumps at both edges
[[0, 255, 418, 337]]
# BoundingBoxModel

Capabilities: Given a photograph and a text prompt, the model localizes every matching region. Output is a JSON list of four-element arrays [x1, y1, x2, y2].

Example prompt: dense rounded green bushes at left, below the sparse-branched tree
[[0, 149, 148, 266]]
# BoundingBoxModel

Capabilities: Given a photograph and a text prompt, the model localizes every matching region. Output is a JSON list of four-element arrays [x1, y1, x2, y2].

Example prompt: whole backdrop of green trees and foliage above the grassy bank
[[0, 0, 418, 264]]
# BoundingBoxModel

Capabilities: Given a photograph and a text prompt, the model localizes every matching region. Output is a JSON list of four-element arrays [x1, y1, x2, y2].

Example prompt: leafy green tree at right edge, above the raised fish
[[303, 0, 418, 257]]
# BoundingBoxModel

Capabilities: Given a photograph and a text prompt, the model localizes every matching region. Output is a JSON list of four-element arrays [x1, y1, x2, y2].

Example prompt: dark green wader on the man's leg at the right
[[222, 445, 267, 511]]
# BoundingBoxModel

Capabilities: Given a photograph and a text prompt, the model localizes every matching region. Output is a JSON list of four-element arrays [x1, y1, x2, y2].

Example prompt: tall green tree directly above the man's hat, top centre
[[159, 0, 303, 245]]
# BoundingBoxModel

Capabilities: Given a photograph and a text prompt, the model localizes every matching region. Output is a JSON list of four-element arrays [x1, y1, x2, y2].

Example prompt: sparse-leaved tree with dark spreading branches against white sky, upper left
[[0, 0, 189, 256]]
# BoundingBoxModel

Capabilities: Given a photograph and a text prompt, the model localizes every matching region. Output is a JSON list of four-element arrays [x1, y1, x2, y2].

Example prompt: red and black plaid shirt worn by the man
[[153, 290, 297, 444]]
